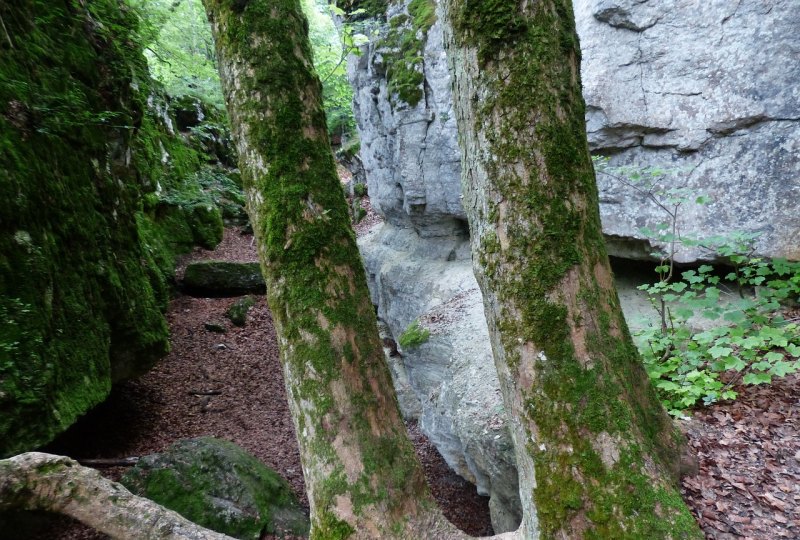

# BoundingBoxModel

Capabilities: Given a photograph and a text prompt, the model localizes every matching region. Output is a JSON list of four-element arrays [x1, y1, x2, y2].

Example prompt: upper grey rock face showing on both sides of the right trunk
[[350, 0, 800, 261]]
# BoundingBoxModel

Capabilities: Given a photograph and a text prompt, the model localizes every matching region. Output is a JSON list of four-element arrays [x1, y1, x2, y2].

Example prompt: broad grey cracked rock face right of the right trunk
[[575, 0, 800, 261]]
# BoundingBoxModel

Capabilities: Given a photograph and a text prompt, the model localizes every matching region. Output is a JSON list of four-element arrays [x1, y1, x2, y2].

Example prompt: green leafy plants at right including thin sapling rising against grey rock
[[595, 158, 800, 415]]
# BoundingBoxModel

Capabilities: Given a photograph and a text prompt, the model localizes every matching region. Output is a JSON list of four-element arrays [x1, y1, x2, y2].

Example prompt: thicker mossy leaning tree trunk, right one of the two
[[444, 0, 700, 539]]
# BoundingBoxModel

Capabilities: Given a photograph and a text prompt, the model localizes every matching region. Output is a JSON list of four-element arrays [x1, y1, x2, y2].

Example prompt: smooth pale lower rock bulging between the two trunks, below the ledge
[[359, 224, 521, 532]]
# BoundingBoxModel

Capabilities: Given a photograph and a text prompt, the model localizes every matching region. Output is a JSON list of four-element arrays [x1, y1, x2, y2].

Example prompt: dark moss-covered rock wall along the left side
[[0, 0, 236, 457]]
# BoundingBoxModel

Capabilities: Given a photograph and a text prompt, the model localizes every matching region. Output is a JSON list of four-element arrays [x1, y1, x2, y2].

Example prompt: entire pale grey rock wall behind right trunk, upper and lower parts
[[349, 0, 800, 532]]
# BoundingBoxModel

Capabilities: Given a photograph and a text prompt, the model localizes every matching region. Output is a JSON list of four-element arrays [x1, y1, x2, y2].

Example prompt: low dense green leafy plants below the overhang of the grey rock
[[636, 254, 800, 416]]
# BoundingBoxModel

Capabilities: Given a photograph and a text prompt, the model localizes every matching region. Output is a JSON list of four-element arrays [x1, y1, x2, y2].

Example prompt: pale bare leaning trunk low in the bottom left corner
[[0, 452, 232, 540]]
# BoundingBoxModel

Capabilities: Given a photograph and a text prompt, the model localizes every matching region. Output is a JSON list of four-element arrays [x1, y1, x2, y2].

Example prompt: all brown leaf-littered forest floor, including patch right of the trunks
[[40, 199, 800, 540]]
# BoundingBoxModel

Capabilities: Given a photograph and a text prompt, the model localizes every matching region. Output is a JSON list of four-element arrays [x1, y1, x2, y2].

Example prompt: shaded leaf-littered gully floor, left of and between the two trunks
[[37, 229, 491, 540]]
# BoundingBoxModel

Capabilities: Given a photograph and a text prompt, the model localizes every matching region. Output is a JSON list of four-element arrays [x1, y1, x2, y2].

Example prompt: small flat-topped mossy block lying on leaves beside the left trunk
[[183, 261, 266, 296]]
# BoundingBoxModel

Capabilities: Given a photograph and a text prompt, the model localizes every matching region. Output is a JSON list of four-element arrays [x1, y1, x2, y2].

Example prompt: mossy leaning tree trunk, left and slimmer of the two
[[199, 0, 460, 538]]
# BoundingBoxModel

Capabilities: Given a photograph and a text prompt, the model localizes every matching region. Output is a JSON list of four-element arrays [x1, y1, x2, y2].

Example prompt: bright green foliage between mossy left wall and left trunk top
[[129, 0, 225, 110]]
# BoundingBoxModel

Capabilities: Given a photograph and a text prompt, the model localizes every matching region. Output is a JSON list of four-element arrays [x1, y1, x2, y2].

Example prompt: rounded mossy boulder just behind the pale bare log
[[122, 437, 309, 540]]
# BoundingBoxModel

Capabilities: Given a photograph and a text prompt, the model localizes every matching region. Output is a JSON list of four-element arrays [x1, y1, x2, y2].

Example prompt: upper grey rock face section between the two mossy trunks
[[348, 4, 466, 237]]
